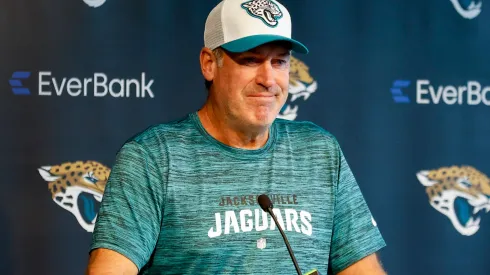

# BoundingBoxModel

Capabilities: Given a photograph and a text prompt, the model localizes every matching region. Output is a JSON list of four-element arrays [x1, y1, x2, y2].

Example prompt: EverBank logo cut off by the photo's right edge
[[391, 79, 490, 106]]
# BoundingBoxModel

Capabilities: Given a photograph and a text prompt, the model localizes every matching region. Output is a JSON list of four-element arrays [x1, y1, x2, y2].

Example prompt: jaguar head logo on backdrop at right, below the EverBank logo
[[417, 166, 490, 236]]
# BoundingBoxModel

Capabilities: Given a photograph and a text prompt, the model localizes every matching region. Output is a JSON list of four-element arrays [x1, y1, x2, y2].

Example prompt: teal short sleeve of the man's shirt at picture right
[[330, 144, 386, 274]]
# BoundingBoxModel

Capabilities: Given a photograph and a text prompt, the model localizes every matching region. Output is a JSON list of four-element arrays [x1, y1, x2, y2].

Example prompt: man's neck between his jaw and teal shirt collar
[[197, 105, 269, 150]]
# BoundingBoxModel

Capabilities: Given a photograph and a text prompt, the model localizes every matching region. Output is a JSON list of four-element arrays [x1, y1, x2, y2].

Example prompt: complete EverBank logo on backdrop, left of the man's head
[[9, 71, 155, 98]]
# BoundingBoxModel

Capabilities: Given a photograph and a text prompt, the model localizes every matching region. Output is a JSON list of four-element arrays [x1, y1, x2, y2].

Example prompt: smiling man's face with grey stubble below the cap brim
[[212, 43, 290, 128]]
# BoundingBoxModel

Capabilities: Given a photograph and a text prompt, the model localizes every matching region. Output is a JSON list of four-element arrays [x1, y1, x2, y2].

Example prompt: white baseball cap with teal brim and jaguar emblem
[[204, 0, 308, 54]]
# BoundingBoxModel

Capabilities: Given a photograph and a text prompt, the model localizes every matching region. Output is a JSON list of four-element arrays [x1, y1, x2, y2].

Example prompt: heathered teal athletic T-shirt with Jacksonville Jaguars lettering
[[90, 113, 386, 275]]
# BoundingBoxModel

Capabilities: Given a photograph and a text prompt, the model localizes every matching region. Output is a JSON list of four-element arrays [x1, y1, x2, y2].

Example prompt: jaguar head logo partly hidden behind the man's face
[[277, 56, 318, 120]]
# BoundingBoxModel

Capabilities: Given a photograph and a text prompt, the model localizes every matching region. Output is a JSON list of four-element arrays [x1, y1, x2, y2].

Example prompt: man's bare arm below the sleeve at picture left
[[85, 248, 138, 275]]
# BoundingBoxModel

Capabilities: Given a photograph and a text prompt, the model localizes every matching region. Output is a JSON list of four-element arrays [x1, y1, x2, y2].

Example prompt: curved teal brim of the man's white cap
[[221, 34, 308, 54]]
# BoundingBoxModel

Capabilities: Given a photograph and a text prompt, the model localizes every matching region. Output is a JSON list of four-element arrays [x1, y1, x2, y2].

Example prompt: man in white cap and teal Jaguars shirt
[[87, 0, 385, 275]]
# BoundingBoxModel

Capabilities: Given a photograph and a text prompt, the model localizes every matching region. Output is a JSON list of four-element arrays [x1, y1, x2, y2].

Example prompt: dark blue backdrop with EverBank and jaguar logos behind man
[[0, 0, 490, 275]]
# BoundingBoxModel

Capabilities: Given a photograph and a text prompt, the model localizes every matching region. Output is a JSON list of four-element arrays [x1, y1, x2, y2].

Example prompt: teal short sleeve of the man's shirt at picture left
[[90, 141, 165, 270]]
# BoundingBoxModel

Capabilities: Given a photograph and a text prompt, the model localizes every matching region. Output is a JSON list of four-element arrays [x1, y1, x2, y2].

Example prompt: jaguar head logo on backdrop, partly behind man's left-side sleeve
[[38, 161, 111, 232]]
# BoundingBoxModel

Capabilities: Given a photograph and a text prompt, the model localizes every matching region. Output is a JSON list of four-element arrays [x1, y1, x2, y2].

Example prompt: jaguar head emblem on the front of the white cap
[[242, 0, 282, 27]]
